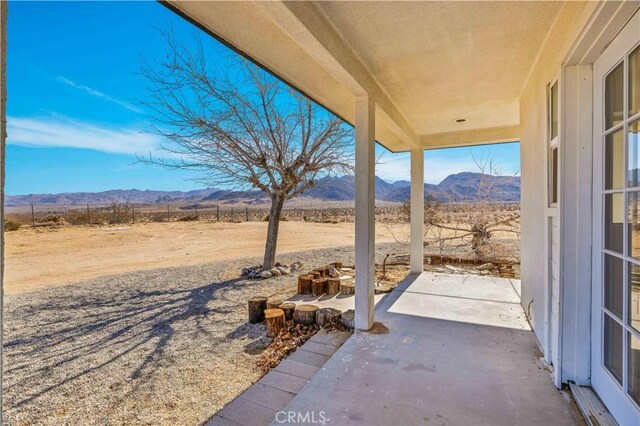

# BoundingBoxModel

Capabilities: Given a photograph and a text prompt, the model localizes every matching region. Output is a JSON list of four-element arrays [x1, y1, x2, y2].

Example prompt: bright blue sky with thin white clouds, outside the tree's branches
[[6, 1, 520, 195]]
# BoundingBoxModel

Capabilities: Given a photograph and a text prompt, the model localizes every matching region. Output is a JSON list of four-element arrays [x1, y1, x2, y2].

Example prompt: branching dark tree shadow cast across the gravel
[[4, 279, 252, 408]]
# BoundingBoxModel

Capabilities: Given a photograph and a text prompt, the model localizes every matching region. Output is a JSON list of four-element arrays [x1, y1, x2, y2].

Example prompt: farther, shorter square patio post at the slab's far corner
[[409, 148, 424, 273]]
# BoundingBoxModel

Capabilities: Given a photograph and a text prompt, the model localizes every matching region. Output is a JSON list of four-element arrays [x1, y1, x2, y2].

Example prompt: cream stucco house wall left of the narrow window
[[520, 2, 594, 350]]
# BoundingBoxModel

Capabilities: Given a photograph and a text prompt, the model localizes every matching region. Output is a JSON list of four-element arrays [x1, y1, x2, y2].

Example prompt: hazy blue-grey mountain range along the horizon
[[5, 172, 520, 207]]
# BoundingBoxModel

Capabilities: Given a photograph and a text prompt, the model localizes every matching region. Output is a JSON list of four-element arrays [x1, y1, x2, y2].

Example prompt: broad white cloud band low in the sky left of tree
[[7, 116, 160, 154]]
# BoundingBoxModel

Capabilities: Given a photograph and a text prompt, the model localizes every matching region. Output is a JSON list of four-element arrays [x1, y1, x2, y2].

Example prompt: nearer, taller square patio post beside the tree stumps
[[355, 96, 375, 330]]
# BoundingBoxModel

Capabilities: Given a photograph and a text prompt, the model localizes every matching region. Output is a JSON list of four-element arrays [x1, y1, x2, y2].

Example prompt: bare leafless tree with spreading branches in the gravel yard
[[141, 32, 353, 269]]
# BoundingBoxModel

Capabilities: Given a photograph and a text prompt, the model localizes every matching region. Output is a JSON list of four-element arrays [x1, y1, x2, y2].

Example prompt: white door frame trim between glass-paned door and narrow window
[[556, 1, 640, 402]]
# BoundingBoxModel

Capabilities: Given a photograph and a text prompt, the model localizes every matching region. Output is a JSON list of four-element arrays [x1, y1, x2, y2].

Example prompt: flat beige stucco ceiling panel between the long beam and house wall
[[316, 2, 563, 135]]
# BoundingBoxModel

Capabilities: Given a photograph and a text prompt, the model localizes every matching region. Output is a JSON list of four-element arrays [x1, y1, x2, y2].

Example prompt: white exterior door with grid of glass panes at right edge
[[591, 12, 640, 425]]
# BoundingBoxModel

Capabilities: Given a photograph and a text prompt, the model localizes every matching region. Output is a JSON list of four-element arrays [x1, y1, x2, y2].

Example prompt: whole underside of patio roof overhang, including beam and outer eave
[[167, 1, 592, 152]]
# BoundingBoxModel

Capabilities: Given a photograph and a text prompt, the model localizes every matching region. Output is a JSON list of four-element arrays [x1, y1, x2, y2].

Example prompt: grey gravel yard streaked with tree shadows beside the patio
[[3, 244, 406, 425]]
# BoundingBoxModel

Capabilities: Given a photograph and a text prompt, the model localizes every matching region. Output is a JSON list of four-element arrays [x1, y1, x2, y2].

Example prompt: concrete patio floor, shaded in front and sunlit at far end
[[272, 273, 581, 425]]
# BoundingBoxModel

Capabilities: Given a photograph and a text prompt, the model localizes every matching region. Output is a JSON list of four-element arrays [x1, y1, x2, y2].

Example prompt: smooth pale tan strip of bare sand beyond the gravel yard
[[4, 222, 404, 294]]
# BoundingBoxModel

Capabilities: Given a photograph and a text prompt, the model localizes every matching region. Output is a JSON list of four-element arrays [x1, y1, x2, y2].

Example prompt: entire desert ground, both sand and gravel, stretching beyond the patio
[[3, 202, 519, 425]]
